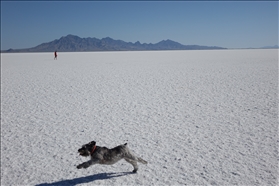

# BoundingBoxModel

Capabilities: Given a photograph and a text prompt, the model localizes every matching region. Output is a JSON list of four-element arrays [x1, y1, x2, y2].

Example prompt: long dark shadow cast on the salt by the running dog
[[36, 172, 134, 186]]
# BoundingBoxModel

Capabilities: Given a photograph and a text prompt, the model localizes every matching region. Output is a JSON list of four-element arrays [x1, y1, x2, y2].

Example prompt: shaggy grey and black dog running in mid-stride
[[77, 141, 147, 173]]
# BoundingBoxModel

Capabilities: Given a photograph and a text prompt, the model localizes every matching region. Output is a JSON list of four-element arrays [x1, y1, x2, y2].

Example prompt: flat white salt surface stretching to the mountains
[[1, 50, 278, 186]]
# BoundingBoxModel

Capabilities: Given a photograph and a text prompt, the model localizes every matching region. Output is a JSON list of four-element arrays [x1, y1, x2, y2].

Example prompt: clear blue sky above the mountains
[[1, 1, 278, 50]]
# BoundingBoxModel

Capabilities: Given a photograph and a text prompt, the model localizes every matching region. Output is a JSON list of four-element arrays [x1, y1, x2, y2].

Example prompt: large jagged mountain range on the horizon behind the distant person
[[1, 35, 226, 52]]
